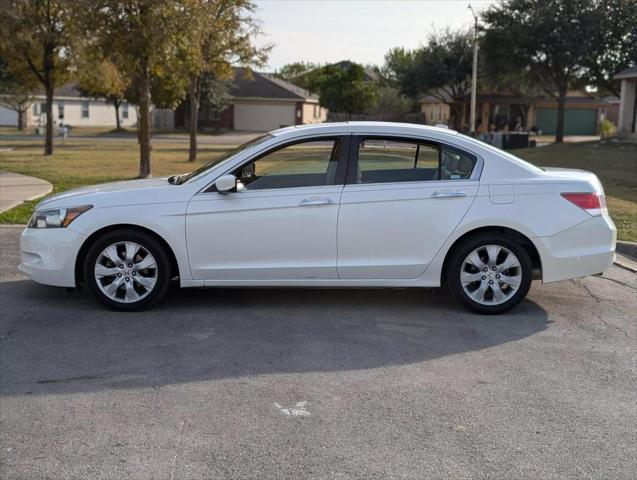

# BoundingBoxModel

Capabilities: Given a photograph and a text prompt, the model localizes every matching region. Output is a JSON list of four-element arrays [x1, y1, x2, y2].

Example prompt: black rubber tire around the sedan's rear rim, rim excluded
[[446, 233, 533, 315]]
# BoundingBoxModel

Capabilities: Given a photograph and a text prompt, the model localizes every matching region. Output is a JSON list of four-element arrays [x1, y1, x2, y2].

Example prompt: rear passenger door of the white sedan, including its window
[[338, 136, 479, 279]]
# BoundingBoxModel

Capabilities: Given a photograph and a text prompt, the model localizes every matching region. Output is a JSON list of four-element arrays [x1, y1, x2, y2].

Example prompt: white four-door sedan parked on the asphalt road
[[20, 122, 616, 313]]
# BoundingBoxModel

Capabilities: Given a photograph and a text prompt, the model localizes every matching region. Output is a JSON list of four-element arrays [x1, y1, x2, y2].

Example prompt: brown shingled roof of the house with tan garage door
[[230, 68, 318, 101]]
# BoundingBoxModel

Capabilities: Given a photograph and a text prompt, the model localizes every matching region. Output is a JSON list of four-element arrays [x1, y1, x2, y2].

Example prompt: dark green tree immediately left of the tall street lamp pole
[[383, 30, 473, 129]]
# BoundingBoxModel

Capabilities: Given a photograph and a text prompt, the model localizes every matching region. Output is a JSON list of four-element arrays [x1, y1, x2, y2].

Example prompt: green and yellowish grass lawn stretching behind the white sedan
[[0, 136, 637, 241]]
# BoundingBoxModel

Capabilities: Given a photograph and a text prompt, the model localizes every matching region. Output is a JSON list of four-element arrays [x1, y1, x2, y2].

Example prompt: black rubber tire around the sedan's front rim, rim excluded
[[83, 229, 172, 311]]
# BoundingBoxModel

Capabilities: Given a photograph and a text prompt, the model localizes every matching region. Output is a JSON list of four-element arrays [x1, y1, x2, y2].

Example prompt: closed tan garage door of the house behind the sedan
[[234, 103, 295, 132]]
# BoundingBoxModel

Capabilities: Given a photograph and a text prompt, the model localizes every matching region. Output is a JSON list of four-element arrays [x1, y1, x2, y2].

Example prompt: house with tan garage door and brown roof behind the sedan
[[175, 68, 327, 132]]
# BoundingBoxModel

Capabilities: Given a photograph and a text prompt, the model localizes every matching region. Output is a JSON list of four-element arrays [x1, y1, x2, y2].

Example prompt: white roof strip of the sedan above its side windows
[[270, 122, 458, 138]]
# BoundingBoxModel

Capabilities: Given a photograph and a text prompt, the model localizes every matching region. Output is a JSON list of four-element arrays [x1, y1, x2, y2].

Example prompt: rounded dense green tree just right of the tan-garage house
[[316, 63, 377, 117]]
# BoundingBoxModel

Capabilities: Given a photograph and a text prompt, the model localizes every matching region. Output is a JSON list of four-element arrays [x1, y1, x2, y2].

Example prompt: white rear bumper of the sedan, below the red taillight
[[533, 215, 617, 283]]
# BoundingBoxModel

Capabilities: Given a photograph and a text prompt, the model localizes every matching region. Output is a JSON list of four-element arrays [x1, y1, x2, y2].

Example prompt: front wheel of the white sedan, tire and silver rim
[[84, 230, 172, 310]]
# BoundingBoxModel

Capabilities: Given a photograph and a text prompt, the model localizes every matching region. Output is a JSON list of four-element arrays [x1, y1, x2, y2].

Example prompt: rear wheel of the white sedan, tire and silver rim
[[447, 233, 533, 314]]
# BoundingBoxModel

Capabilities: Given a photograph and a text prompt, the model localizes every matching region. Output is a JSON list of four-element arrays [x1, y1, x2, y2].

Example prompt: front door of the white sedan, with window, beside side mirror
[[186, 137, 348, 281]]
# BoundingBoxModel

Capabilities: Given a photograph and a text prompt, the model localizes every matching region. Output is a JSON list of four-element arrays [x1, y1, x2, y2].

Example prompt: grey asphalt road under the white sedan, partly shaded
[[0, 228, 637, 480]]
